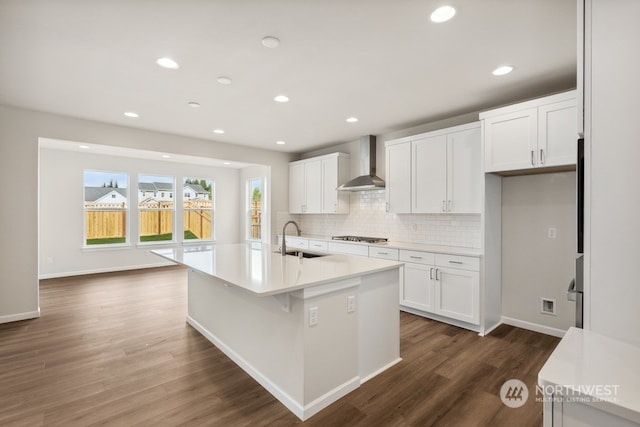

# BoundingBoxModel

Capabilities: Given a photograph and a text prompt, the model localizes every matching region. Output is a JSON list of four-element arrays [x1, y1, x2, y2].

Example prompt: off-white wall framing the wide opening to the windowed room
[[0, 106, 297, 323]]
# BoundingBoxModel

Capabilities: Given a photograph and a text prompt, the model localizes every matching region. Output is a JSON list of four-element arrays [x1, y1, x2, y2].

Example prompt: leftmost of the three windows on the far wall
[[84, 170, 129, 246]]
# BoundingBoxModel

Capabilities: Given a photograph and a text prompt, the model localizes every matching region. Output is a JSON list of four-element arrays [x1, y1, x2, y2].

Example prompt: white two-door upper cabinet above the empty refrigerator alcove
[[480, 90, 578, 172]]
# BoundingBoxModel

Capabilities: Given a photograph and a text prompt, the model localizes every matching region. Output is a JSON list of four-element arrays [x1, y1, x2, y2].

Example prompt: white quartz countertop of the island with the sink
[[151, 243, 403, 296]]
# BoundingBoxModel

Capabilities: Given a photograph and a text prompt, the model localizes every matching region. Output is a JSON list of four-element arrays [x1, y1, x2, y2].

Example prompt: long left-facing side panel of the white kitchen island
[[188, 271, 304, 417]]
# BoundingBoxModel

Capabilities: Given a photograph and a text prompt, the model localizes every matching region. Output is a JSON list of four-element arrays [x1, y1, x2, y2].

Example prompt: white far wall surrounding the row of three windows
[[39, 148, 241, 278]]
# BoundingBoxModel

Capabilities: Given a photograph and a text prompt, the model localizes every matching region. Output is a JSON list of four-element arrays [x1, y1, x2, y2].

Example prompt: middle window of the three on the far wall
[[138, 175, 175, 242]]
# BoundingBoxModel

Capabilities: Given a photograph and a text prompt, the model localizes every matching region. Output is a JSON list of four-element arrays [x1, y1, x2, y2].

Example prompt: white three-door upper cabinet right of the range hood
[[386, 122, 482, 213]]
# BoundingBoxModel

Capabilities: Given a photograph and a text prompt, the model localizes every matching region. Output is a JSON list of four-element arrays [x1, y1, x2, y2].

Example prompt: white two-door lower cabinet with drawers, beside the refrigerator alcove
[[400, 250, 480, 325]]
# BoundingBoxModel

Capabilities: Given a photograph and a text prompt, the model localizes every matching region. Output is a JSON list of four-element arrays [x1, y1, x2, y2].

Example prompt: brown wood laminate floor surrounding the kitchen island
[[0, 267, 559, 427]]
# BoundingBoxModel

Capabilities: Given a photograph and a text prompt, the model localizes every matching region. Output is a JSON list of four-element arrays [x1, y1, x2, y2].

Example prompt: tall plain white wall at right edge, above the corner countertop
[[585, 0, 640, 345]]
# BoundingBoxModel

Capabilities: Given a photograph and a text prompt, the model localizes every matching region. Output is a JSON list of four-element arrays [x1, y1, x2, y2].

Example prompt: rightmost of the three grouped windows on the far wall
[[183, 178, 214, 241]]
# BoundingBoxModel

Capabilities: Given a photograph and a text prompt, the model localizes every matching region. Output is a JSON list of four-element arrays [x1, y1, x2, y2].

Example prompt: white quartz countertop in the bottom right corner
[[538, 325, 640, 423]]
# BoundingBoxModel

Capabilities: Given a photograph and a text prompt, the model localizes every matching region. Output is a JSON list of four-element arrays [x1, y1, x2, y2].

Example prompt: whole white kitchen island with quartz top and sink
[[151, 243, 403, 420]]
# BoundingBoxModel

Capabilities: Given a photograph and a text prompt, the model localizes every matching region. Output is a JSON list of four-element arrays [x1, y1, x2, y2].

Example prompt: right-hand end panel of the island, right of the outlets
[[357, 266, 403, 382]]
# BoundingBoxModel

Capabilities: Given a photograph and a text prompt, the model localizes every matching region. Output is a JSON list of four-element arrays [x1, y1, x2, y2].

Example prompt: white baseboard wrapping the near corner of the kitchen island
[[187, 316, 360, 421]]
